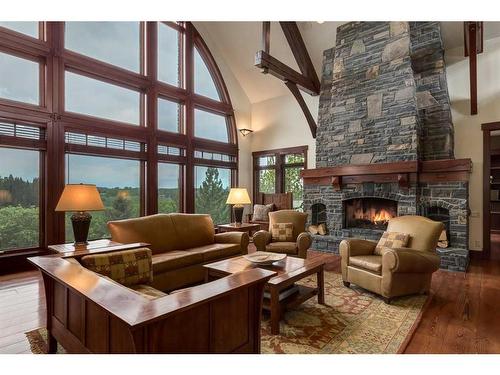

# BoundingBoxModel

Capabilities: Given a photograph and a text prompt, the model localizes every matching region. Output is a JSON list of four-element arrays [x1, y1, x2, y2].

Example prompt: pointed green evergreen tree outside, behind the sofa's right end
[[195, 167, 230, 224]]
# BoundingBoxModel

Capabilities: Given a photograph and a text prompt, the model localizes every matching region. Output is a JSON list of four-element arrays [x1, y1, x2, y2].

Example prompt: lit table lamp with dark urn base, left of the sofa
[[56, 184, 104, 245]]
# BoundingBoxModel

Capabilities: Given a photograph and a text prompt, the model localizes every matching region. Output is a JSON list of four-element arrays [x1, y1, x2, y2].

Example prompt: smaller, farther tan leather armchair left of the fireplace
[[253, 210, 312, 259]]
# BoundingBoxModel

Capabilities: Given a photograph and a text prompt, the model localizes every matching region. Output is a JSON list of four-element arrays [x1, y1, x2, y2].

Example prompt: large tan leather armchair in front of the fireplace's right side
[[340, 216, 444, 303]]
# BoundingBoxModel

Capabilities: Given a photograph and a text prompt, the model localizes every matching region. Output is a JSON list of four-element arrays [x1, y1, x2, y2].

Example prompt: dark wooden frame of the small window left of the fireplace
[[252, 146, 308, 209]]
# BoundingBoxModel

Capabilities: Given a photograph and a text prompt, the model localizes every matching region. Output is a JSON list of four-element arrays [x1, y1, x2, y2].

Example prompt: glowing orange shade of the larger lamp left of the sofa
[[56, 184, 104, 212]]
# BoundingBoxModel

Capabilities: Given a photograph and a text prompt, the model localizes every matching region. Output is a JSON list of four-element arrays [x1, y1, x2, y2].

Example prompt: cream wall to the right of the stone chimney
[[445, 38, 500, 250]]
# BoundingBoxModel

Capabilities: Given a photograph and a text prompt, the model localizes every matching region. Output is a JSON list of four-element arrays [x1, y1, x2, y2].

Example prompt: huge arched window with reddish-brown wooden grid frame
[[0, 22, 238, 250]]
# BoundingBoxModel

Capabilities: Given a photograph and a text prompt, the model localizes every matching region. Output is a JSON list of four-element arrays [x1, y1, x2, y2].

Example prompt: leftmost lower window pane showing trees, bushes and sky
[[0, 148, 39, 250]]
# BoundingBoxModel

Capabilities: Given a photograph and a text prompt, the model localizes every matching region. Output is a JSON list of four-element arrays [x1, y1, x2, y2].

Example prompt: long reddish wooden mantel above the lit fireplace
[[301, 159, 472, 190]]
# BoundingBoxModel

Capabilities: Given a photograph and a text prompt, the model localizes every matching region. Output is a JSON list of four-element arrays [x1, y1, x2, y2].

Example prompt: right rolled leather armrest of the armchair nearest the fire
[[382, 248, 440, 273]]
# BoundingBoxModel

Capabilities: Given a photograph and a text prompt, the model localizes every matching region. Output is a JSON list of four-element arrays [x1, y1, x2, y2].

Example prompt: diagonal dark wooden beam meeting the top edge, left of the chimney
[[280, 22, 320, 92]]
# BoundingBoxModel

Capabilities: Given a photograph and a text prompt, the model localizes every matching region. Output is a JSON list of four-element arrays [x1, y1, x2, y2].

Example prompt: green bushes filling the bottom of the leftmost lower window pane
[[0, 206, 38, 250]]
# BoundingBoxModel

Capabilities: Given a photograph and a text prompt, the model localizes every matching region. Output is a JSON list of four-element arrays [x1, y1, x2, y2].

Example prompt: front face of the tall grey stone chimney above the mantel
[[316, 22, 418, 167]]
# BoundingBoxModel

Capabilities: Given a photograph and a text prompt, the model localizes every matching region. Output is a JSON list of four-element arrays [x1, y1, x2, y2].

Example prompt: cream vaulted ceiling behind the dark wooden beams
[[195, 22, 500, 103]]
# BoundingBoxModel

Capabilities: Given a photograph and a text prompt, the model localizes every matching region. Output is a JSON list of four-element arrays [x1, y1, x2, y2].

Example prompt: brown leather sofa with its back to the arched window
[[108, 213, 249, 292]]
